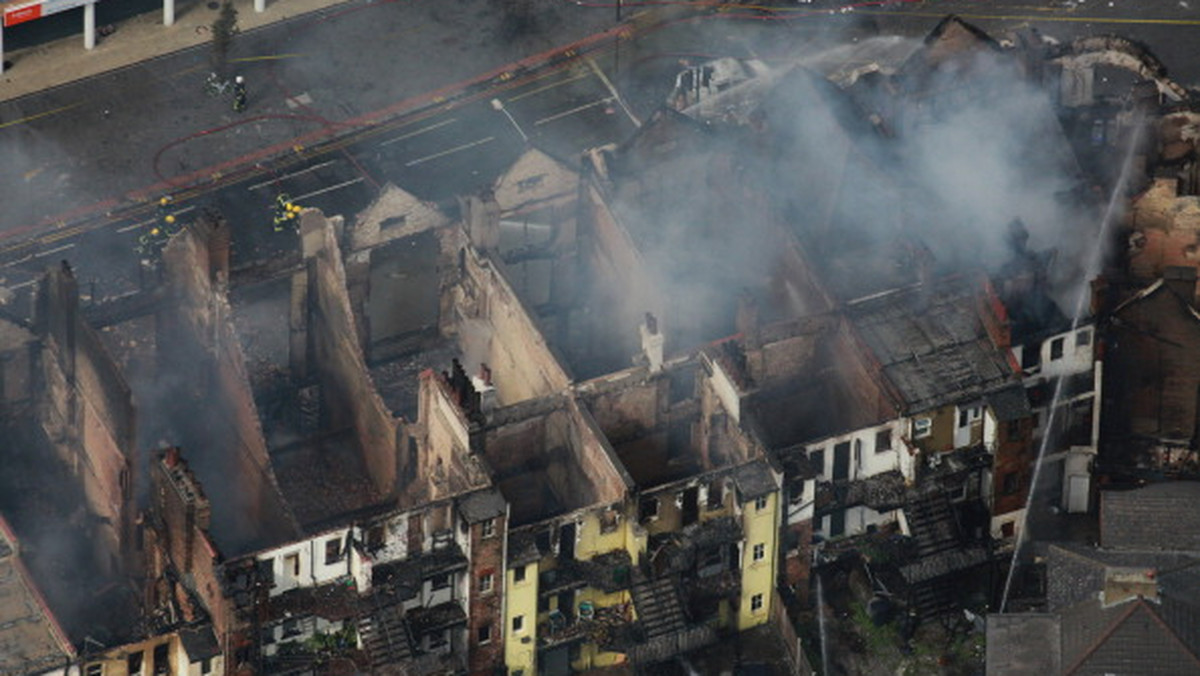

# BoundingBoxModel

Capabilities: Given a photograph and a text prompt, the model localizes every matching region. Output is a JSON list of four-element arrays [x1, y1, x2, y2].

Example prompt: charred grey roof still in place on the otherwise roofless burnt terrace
[[847, 280, 1019, 412]]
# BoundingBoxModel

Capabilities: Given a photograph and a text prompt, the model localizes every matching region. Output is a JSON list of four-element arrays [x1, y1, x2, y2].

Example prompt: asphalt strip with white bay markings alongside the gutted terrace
[[0, 45, 636, 297]]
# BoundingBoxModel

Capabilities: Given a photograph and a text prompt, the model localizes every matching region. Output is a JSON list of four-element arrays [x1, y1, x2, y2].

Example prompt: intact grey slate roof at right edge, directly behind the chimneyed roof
[[1100, 481, 1200, 551]]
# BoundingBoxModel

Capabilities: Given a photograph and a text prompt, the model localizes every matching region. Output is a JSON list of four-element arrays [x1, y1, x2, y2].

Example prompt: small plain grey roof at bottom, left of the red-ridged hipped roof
[[986, 612, 1062, 676]]
